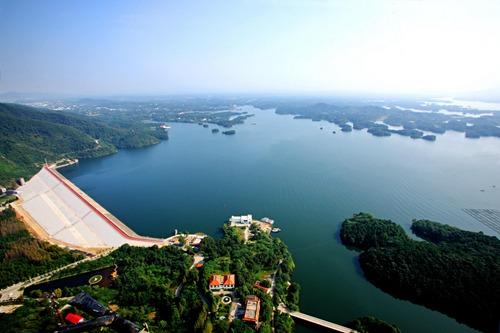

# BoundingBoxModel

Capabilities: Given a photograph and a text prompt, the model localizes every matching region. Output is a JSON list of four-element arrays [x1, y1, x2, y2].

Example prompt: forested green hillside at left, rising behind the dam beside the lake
[[0, 103, 168, 184]]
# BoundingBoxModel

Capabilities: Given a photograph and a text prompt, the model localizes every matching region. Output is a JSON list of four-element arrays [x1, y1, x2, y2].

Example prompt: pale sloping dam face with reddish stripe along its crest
[[17, 166, 164, 249]]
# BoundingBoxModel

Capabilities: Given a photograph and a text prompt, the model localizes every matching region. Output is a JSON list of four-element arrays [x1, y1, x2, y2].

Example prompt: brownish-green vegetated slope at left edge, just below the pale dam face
[[0, 208, 83, 288]]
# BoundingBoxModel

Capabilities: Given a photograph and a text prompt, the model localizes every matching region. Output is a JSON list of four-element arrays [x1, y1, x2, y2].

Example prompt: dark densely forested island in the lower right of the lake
[[340, 213, 500, 333]]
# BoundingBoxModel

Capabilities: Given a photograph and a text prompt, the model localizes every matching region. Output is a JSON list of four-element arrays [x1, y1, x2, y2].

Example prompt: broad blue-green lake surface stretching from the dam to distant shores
[[61, 107, 500, 333]]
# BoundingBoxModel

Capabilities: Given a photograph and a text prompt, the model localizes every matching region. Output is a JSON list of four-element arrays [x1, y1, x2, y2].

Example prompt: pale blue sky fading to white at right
[[0, 0, 500, 98]]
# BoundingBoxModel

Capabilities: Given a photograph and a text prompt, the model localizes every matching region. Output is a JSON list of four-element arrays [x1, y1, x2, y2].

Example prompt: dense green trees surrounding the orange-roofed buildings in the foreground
[[0, 223, 300, 333]]
